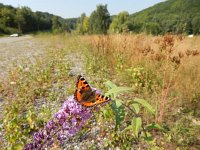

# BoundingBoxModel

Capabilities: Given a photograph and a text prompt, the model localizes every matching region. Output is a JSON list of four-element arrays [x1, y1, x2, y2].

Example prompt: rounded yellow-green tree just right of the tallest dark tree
[[110, 11, 130, 33]]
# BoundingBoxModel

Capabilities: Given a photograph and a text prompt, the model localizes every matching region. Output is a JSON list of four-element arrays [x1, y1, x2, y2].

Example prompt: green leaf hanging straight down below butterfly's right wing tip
[[111, 100, 125, 130]]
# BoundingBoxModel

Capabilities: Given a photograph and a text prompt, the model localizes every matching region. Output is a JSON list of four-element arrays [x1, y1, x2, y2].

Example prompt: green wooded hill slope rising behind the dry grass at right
[[129, 0, 200, 34]]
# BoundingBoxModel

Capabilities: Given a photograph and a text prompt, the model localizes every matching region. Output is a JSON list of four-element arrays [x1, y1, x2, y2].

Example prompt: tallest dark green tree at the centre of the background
[[89, 5, 111, 34]]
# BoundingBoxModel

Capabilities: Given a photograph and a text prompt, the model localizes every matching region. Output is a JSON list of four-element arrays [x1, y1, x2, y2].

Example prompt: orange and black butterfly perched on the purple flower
[[74, 75, 111, 107]]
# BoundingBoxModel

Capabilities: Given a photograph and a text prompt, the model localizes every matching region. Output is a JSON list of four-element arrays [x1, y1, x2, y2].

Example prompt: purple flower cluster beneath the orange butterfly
[[24, 96, 92, 150]]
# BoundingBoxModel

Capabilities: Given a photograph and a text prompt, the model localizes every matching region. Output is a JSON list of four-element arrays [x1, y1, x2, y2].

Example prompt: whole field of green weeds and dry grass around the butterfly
[[0, 34, 200, 150]]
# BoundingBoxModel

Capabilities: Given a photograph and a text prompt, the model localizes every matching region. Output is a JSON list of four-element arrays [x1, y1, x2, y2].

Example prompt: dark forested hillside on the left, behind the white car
[[0, 3, 76, 34]]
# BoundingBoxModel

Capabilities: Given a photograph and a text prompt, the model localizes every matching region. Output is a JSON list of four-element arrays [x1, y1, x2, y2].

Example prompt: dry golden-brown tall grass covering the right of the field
[[80, 34, 200, 122]]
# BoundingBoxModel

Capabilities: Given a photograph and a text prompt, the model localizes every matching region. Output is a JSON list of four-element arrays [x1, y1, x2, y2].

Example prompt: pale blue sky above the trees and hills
[[0, 0, 165, 18]]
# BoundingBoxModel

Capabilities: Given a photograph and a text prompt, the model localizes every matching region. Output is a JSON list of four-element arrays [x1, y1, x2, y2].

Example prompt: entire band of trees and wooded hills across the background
[[0, 0, 200, 35]]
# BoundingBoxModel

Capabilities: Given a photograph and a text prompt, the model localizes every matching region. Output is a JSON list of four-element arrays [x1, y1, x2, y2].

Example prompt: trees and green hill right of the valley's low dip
[[76, 0, 200, 35]]
